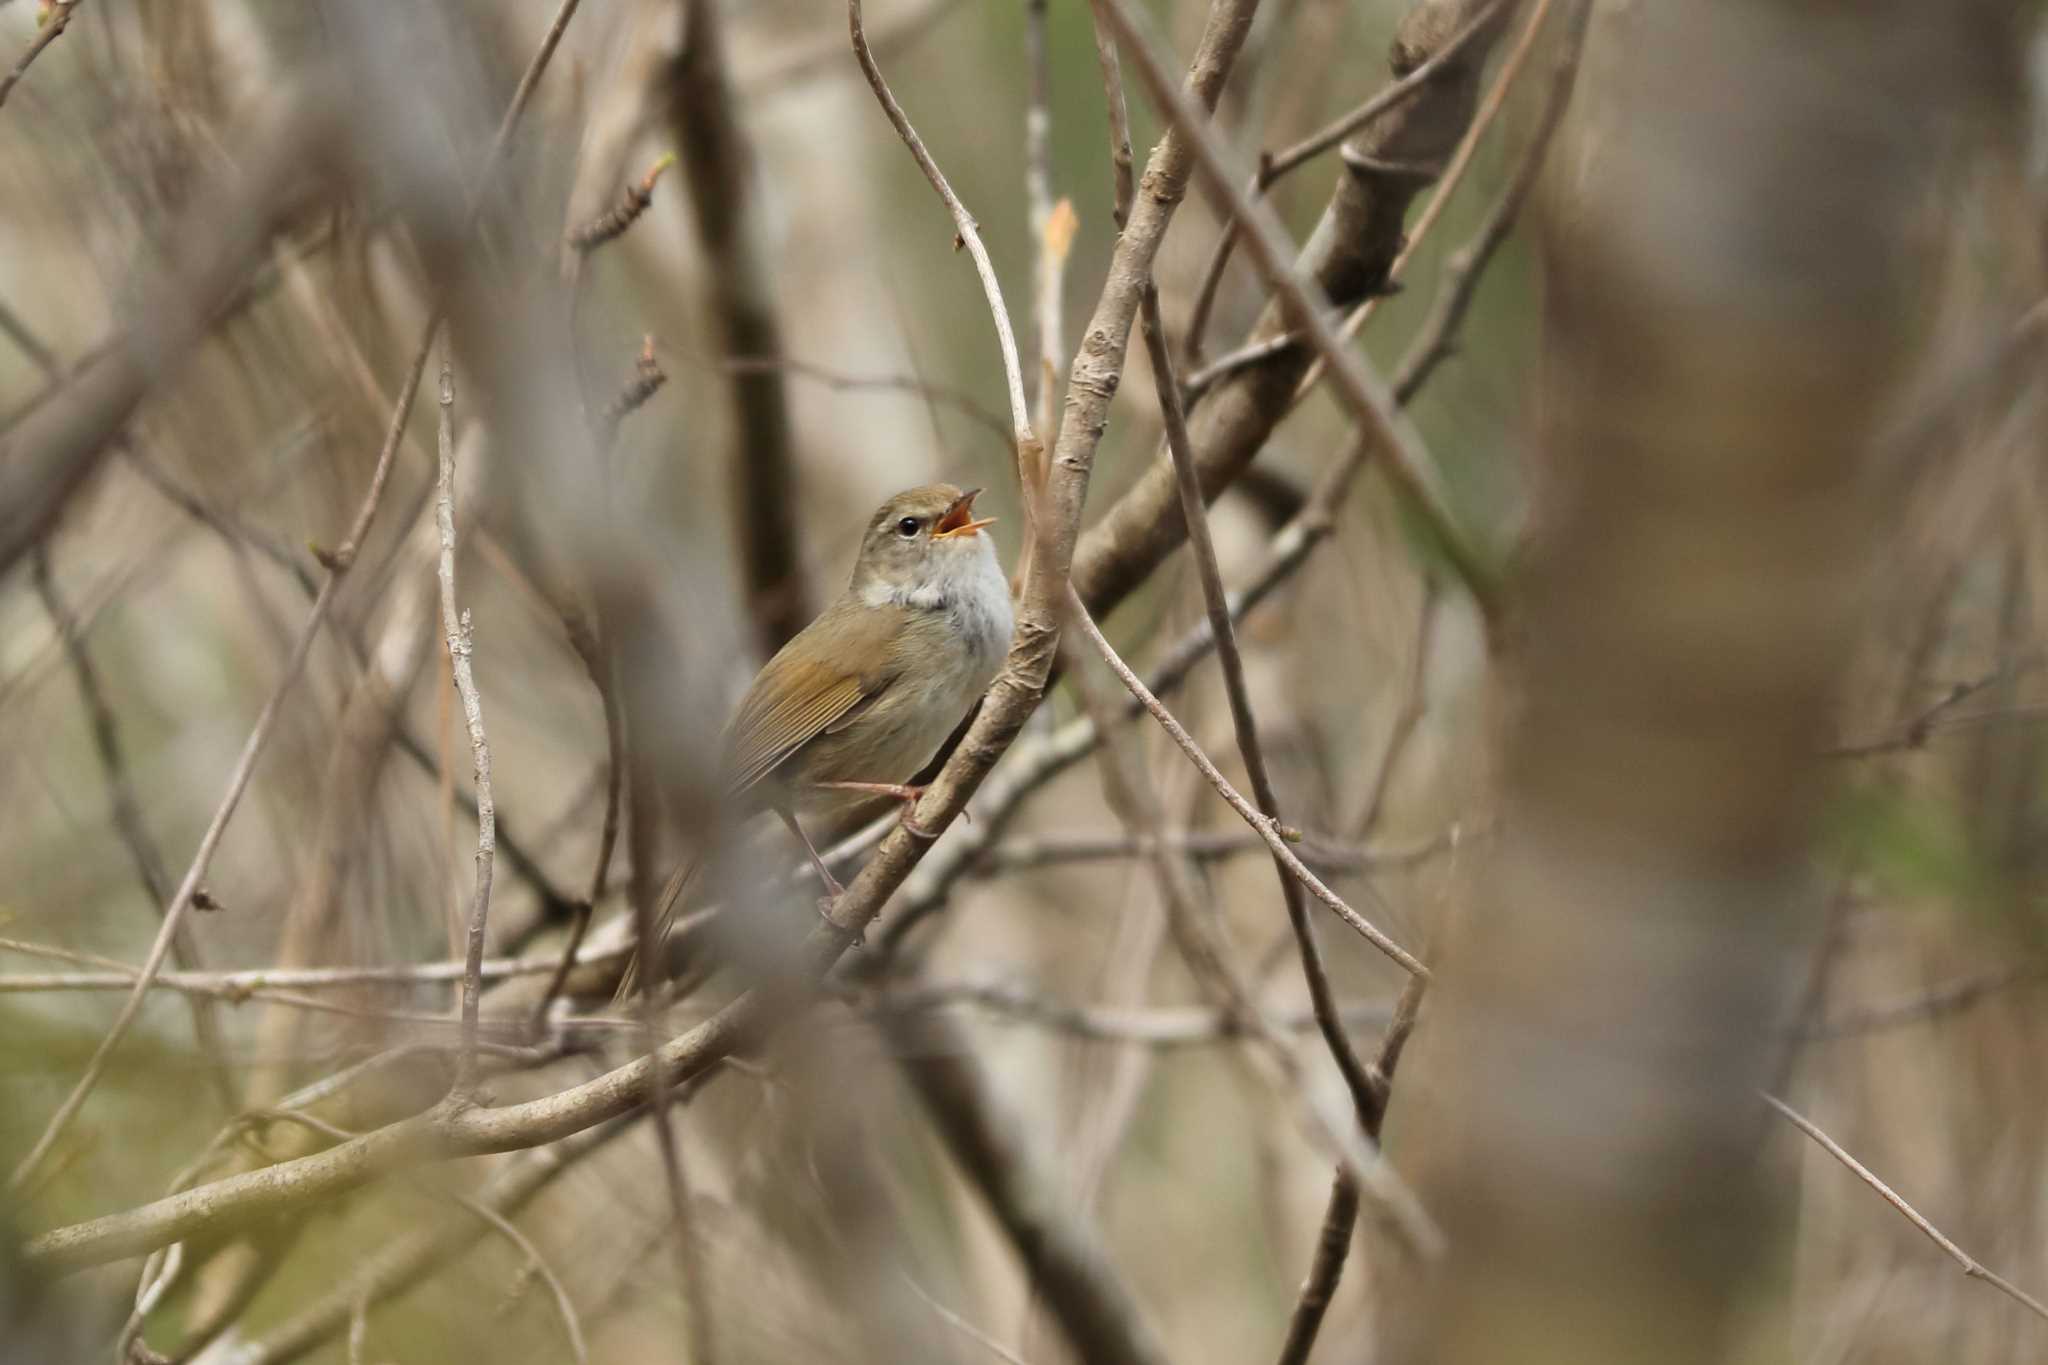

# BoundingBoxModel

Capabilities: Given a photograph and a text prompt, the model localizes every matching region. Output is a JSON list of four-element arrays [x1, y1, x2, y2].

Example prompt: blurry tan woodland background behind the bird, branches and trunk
[[0, 0, 2048, 1363]]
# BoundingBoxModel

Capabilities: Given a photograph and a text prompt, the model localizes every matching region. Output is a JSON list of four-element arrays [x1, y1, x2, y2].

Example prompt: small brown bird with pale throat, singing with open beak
[[621, 483, 1012, 990]]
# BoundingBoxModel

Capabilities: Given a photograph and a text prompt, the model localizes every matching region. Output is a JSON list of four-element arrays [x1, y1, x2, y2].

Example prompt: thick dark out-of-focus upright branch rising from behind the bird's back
[[670, 0, 811, 655]]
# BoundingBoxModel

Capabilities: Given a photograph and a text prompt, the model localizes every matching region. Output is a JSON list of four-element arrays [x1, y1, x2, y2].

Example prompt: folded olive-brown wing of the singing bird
[[725, 600, 903, 796]]
